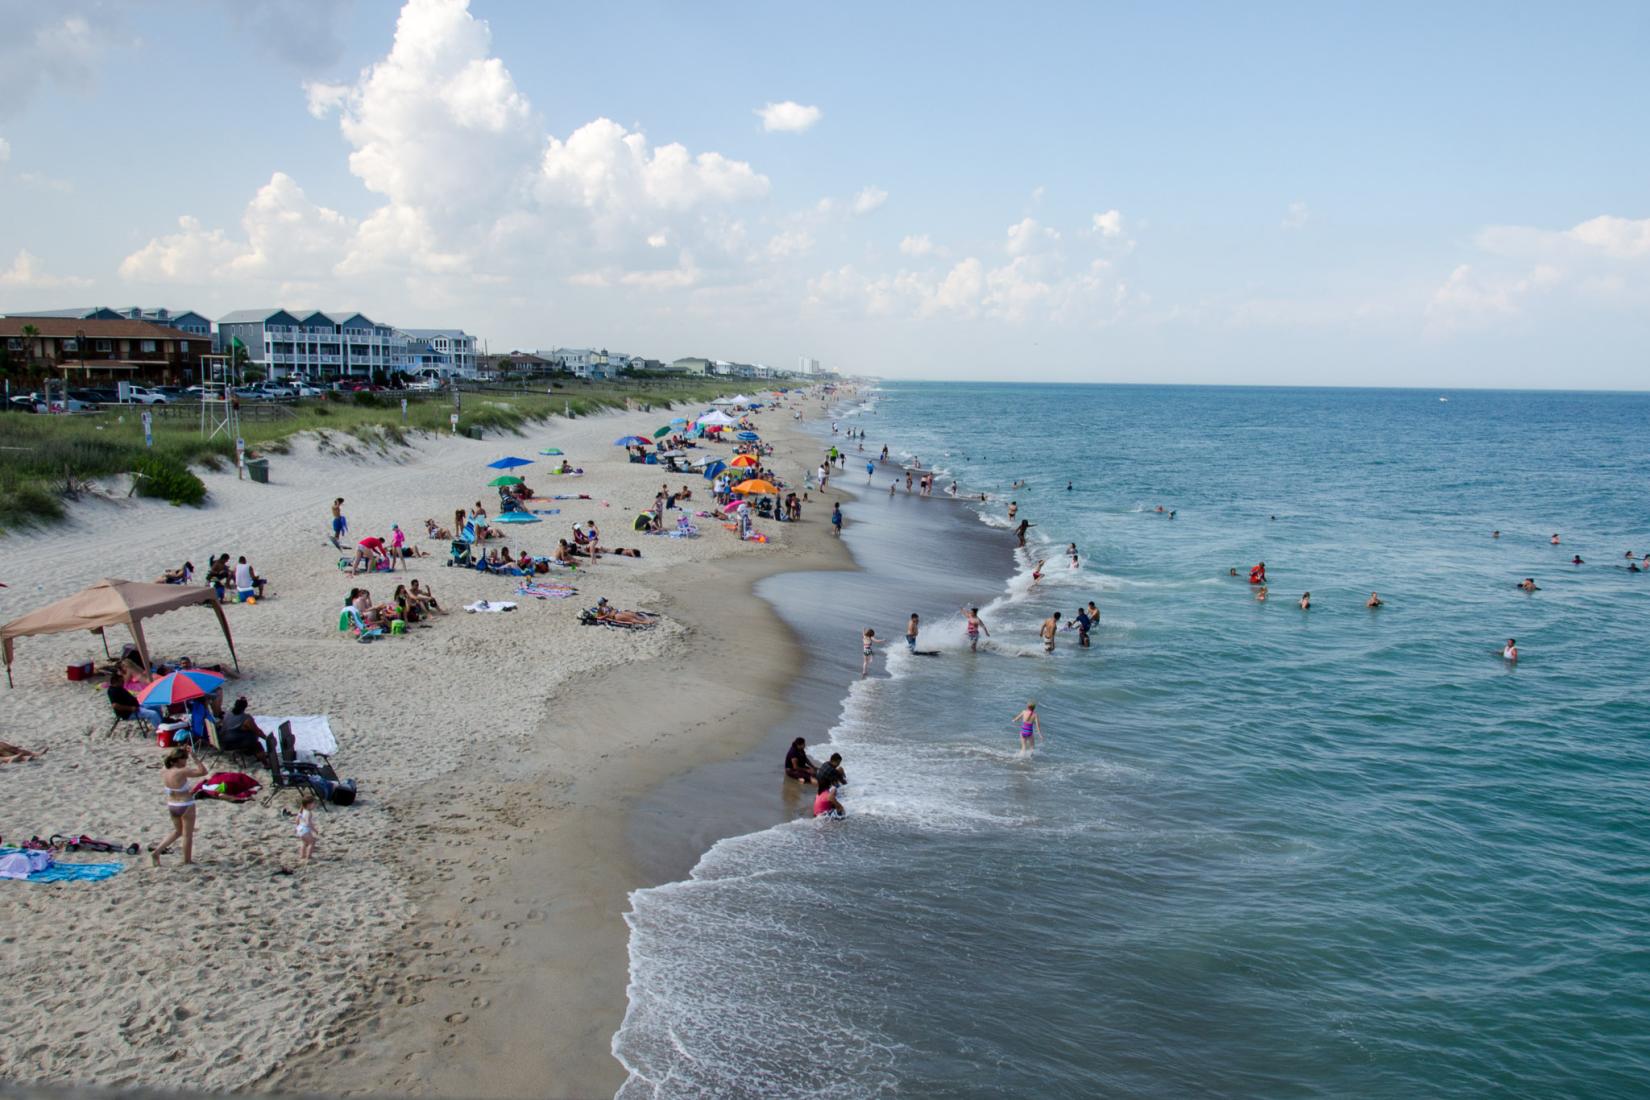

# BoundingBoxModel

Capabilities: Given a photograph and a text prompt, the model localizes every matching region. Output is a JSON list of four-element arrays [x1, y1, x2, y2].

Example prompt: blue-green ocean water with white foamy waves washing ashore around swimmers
[[614, 383, 1650, 1100]]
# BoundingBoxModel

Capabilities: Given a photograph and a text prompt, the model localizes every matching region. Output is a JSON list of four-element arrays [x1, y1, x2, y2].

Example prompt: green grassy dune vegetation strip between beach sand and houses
[[0, 378, 751, 533]]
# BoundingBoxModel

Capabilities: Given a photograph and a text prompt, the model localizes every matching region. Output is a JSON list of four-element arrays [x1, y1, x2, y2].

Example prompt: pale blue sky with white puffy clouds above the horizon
[[0, 0, 1650, 389]]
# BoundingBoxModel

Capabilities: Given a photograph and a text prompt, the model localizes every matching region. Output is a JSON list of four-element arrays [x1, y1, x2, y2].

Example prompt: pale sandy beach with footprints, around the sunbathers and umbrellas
[[0, 390, 850, 1097]]
